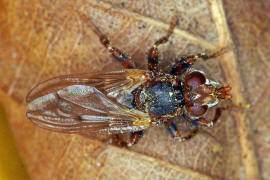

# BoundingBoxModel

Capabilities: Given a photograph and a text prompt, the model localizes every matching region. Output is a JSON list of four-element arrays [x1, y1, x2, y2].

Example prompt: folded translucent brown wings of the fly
[[26, 70, 151, 134]]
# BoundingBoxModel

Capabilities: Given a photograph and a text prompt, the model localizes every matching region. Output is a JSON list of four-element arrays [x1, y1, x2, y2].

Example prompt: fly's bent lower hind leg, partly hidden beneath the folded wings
[[111, 131, 143, 148]]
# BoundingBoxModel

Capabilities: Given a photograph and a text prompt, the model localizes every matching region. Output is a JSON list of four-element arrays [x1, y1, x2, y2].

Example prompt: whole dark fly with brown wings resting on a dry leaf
[[26, 12, 232, 146]]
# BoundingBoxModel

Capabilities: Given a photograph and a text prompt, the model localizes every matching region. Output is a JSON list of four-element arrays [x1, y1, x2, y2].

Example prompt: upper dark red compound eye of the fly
[[185, 71, 206, 88]]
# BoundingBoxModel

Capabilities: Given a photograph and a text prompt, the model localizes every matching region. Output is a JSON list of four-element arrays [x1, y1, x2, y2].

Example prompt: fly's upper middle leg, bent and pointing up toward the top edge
[[148, 16, 177, 72]]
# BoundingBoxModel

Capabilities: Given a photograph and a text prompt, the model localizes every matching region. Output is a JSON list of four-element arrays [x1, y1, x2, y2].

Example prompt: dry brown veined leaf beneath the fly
[[0, 0, 270, 180]]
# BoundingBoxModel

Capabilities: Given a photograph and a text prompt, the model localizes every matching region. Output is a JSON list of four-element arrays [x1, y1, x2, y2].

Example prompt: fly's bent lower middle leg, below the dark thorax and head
[[165, 120, 199, 142]]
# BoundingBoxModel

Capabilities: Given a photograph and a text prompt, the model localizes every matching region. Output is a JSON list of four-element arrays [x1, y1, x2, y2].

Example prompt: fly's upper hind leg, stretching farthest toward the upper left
[[78, 12, 135, 69]]
